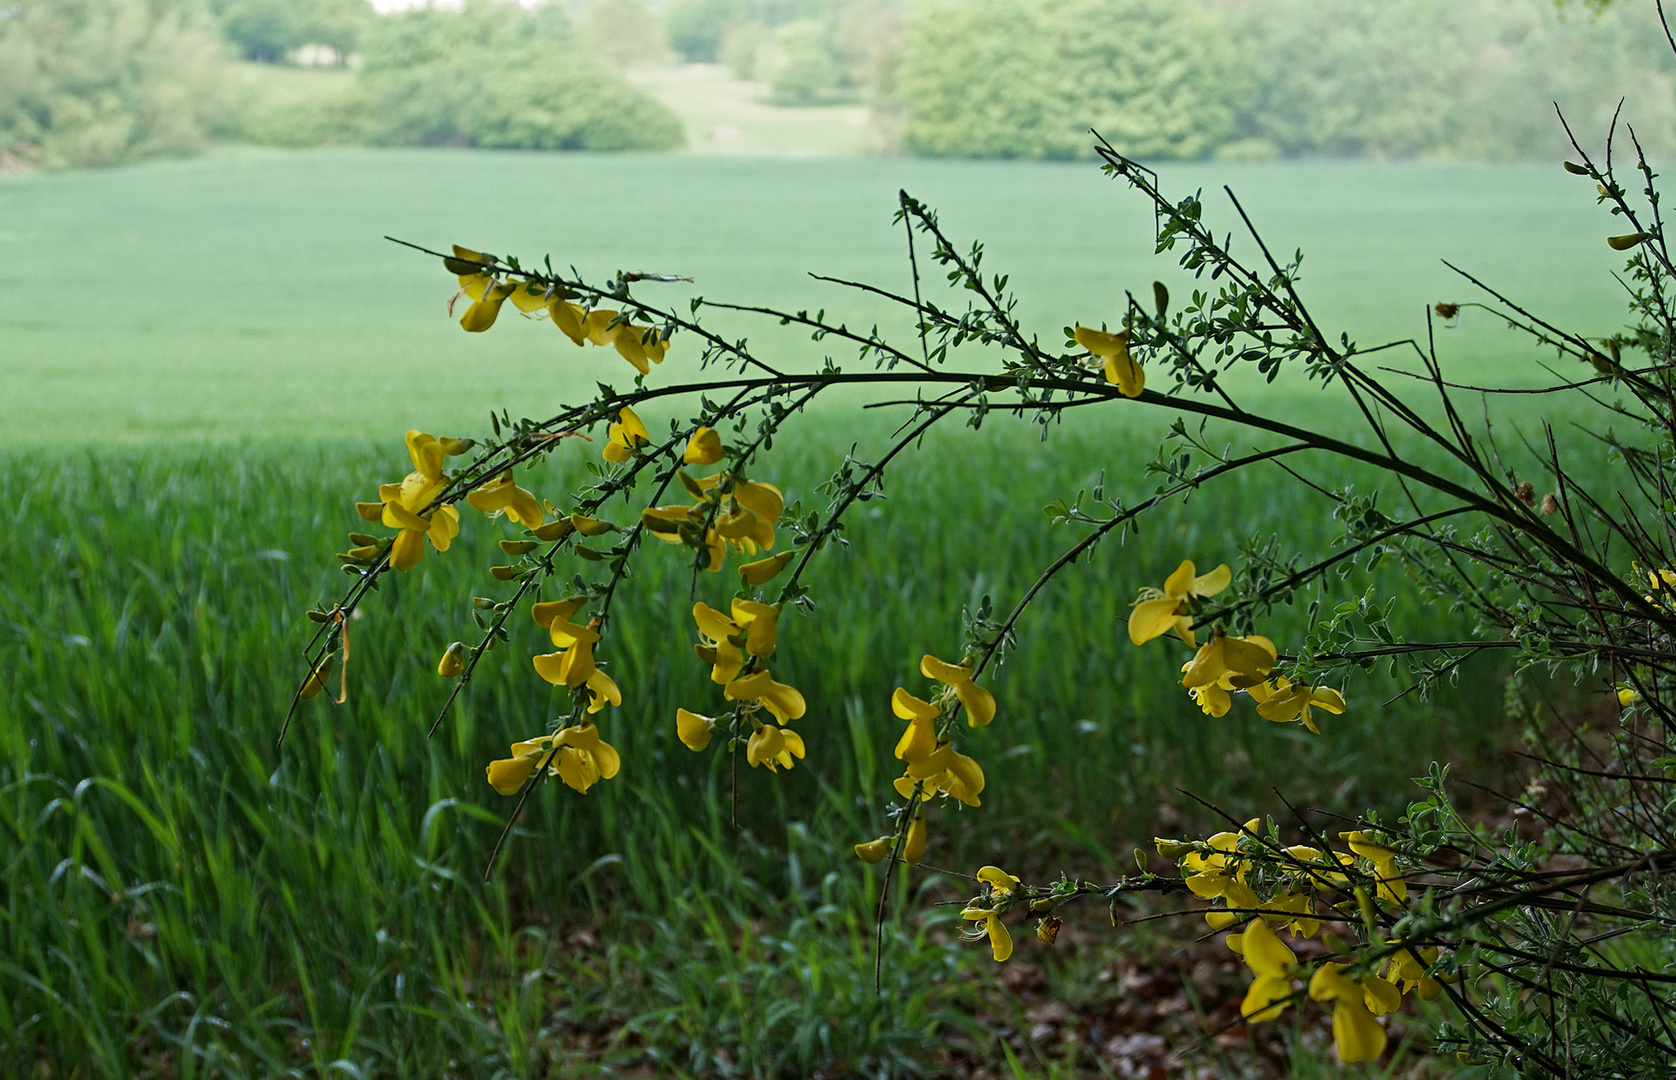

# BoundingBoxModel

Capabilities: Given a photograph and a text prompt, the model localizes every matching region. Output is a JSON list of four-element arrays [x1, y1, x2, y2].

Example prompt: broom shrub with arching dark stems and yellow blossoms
[[294, 57, 1676, 1077]]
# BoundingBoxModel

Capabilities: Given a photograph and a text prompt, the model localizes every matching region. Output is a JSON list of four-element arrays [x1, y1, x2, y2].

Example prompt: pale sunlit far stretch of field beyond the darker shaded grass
[[0, 149, 1624, 446]]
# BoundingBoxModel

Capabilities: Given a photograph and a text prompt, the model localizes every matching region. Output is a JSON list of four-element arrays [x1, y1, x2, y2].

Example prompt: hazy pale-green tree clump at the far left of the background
[[0, 0, 226, 169]]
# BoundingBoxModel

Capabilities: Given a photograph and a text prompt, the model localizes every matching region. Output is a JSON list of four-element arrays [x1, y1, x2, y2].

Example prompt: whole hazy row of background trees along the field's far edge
[[0, 0, 1676, 168]]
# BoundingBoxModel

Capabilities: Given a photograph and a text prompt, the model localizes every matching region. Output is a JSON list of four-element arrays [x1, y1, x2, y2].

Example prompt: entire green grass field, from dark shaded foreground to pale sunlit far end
[[0, 151, 1621, 1077]]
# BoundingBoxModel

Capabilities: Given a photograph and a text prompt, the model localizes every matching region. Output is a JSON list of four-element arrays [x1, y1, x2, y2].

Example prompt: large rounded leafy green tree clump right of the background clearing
[[897, 0, 1230, 158]]
